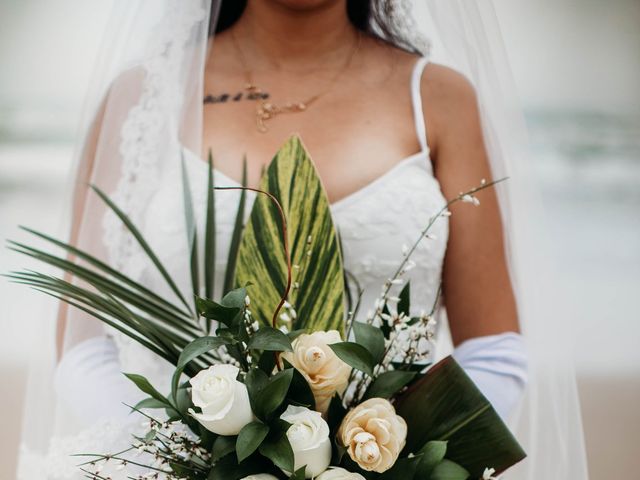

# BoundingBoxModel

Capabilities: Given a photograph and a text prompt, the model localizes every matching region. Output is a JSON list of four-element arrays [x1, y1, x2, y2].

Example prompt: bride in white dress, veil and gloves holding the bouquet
[[20, 0, 586, 479]]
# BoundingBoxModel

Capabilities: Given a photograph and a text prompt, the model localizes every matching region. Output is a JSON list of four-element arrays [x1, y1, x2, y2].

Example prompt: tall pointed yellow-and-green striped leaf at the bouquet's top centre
[[236, 136, 344, 333]]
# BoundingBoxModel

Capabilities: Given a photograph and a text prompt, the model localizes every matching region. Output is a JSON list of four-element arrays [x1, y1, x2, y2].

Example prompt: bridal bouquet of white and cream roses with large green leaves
[[10, 137, 524, 480]]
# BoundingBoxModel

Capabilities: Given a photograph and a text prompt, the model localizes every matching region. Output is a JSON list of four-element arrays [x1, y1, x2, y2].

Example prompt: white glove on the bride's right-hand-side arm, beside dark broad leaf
[[453, 332, 527, 420]]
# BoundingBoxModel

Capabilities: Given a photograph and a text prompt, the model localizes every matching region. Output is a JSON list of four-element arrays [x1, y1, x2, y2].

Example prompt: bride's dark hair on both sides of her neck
[[210, 0, 421, 54]]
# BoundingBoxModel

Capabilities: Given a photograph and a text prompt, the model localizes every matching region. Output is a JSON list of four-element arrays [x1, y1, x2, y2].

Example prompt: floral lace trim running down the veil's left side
[[103, 0, 207, 275]]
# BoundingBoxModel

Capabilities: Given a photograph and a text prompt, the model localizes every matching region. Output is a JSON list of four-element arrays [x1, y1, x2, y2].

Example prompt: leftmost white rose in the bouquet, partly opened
[[189, 365, 255, 435]]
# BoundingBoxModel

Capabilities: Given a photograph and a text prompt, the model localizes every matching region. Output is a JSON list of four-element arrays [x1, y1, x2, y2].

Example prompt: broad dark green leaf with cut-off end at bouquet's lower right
[[396, 356, 526, 478]]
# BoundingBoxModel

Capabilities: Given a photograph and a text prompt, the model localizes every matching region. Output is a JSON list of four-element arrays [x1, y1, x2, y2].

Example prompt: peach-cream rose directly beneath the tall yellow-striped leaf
[[282, 330, 351, 413]]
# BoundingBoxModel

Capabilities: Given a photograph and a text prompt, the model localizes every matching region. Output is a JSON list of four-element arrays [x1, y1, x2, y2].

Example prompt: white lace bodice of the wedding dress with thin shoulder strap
[[118, 60, 448, 387]]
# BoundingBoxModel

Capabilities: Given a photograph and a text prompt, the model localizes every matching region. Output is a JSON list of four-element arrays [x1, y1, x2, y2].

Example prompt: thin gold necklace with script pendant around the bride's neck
[[231, 32, 362, 133]]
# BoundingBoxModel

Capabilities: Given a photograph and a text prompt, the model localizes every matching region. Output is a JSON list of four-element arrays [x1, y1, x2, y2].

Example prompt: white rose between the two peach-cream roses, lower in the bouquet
[[280, 405, 331, 478]]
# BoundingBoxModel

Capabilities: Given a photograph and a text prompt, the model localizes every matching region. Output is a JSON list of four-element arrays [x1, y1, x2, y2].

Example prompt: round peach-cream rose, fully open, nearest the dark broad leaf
[[338, 398, 407, 473]]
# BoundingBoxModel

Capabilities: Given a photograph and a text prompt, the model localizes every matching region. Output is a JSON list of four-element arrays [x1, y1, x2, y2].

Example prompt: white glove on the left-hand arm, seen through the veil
[[54, 336, 141, 424]]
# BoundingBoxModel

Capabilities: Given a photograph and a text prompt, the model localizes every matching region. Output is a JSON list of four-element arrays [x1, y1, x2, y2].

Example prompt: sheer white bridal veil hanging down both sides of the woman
[[19, 0, 587, 480]]
